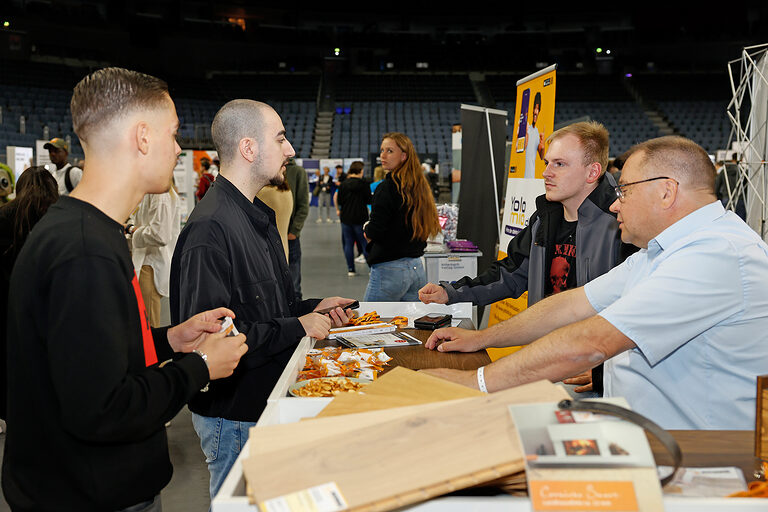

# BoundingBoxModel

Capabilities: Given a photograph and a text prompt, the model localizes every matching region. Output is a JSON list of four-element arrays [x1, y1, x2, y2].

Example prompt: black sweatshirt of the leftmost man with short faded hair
[[3, 197, 208, 511]]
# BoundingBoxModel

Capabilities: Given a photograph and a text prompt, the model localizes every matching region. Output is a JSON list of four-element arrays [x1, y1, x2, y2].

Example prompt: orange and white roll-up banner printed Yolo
[[488, 65, 557, 361]]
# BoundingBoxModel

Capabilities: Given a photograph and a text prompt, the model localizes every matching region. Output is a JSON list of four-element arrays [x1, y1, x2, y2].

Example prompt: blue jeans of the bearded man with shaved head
[[192, 413, 256, 499]]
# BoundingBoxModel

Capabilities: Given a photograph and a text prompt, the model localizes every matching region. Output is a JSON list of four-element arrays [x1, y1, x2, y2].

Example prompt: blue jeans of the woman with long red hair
[[363, 258, 427, 302]]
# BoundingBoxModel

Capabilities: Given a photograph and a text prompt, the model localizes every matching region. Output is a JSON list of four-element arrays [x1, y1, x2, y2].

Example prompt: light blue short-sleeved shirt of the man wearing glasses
[[585, 201, 768, 430]]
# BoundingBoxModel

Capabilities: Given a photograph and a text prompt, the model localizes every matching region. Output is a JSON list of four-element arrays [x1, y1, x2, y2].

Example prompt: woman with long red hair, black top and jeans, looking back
[[363, 132, 440, 301]]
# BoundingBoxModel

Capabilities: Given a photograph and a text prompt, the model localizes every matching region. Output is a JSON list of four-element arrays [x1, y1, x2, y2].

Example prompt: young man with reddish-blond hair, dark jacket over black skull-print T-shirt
[[419, 122, 636, 391]]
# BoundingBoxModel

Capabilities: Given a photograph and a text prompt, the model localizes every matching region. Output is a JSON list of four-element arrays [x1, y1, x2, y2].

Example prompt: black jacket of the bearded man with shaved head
[[170, 174, 320, 421]]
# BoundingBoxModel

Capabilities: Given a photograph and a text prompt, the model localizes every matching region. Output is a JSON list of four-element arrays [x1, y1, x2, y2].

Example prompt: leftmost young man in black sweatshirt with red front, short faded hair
[[3, 68, 247, 512]]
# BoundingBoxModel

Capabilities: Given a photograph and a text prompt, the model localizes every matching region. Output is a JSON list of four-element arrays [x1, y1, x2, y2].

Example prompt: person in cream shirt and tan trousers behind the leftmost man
[[125, 181, 181, 327]]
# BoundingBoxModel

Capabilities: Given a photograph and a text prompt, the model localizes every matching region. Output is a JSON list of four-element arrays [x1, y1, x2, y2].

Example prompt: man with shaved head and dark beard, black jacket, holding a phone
[[171, 99, 351, 498]]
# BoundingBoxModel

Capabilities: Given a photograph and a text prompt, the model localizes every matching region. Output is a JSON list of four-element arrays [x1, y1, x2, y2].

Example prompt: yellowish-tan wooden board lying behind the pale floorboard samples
[[317, 367, 483, 417]]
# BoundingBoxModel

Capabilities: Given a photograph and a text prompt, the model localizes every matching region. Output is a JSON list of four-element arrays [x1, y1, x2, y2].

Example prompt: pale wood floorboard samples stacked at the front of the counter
[[243, 381, 568, 510]]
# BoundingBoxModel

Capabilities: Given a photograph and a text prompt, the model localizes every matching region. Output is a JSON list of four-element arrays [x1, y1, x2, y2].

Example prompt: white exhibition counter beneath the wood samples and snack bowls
[[211, 302, 768, 512]]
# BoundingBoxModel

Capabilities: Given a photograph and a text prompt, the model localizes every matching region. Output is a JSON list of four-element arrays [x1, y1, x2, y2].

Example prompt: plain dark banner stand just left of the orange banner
[[456, 107, 508, 274]]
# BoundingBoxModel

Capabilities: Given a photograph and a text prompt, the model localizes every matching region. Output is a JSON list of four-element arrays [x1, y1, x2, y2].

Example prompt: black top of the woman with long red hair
[[365, 173, 427, 265]]
